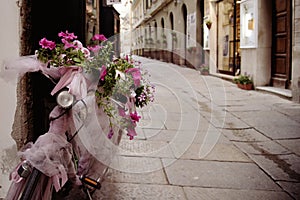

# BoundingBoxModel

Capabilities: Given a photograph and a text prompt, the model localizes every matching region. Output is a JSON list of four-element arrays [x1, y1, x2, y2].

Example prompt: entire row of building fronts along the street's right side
[[131, 0, 300, 102]]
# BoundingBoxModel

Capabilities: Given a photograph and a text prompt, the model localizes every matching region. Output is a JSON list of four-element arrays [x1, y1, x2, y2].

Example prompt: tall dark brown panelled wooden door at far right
[[271, 0, 292, 89]]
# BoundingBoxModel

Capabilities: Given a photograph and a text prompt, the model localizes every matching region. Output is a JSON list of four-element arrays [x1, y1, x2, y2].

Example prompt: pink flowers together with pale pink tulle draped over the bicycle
[[5, 31, 155, 199]]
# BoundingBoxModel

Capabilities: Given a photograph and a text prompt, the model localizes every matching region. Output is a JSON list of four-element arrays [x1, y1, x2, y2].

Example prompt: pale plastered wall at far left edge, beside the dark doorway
[[0, 0, 19, 198]]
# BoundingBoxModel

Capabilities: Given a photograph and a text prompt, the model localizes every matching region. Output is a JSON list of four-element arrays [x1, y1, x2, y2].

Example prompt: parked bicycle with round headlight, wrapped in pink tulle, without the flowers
[[7, 75, 120, 200]]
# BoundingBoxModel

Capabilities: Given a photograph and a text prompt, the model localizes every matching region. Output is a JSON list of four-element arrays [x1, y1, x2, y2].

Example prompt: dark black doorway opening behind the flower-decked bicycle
[[19, 0, 86, 143]]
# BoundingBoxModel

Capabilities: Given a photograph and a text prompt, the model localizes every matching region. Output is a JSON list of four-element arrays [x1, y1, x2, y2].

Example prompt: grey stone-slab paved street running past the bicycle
[[94, 57, 300, 200]]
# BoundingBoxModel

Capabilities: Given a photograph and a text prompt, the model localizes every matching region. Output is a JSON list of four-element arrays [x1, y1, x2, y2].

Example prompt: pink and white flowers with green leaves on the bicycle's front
[[36, 31, 155, 139]]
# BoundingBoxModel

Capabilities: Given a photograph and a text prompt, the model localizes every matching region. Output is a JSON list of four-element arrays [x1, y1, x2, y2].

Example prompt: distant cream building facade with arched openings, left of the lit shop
[[131, 0, 205, 68]]
